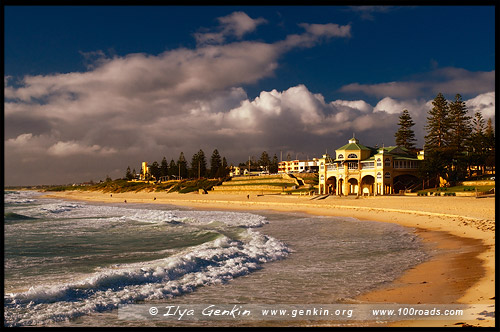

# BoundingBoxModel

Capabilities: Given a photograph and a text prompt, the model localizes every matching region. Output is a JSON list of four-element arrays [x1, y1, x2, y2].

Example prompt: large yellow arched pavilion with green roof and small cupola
[[319, 138, 423, 196]]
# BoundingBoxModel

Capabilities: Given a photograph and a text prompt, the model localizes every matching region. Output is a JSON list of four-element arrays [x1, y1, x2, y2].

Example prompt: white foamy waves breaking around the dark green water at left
[[4, 194, 290, 326]]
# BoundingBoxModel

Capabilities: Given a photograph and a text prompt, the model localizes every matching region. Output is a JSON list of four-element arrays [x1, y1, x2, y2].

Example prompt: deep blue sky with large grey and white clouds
[[4, 5, 495, 186]]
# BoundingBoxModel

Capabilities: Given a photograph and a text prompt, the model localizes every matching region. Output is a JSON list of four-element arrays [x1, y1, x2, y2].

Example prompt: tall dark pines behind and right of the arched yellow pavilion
[[394, 93, 495, 184]]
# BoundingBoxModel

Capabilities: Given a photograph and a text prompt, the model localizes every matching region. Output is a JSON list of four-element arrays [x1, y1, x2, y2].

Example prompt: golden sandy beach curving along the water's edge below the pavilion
[[41, 191, 495, 327]]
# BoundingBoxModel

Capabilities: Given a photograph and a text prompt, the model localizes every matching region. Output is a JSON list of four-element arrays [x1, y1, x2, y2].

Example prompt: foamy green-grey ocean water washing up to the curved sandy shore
[[4, 191, 432, 326]]
